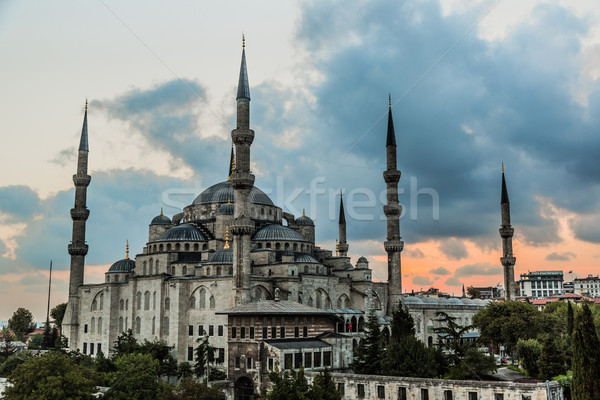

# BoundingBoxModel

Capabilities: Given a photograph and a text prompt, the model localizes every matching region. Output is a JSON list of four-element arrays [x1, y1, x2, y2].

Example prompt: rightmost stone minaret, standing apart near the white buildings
[[500, 164, 517, 300]]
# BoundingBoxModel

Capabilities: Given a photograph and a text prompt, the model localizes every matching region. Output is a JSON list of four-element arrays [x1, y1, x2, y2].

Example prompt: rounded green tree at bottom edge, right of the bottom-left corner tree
[[105, 353, 160, 400]]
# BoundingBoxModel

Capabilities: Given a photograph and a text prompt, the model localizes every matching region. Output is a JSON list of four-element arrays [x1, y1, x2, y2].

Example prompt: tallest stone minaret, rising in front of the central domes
[[230, 39, 254, 305]]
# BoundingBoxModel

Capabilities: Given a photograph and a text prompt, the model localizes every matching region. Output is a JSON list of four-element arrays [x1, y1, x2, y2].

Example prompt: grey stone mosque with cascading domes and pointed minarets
[[63, 41, 514, 398]]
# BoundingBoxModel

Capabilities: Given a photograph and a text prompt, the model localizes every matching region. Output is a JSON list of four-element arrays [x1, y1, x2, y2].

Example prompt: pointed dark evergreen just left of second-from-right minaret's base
[[350, 310, 384, 375]]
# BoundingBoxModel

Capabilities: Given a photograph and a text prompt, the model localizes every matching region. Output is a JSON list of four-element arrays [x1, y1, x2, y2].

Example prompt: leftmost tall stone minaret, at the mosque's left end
[[65, 100, 92, 349]]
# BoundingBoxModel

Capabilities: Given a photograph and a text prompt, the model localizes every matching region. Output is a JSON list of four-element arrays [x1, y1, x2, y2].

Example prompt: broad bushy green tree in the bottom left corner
[[4, 352, 96, 400]]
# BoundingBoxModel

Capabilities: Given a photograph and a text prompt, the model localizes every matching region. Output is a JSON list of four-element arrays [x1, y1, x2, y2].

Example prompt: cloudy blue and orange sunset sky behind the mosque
[[0, 0, 600, 321]]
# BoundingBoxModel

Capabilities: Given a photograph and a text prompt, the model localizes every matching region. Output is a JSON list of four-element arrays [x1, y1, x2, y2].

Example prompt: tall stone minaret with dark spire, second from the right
[[383, 96, 404, 315]]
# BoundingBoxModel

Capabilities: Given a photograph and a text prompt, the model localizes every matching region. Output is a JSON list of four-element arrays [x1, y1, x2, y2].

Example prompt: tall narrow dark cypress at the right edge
[[571, 304, 600, 400]]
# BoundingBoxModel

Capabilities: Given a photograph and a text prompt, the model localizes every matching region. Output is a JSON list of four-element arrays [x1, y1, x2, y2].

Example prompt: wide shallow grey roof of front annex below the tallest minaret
[[216, 300, 337, 319]]
